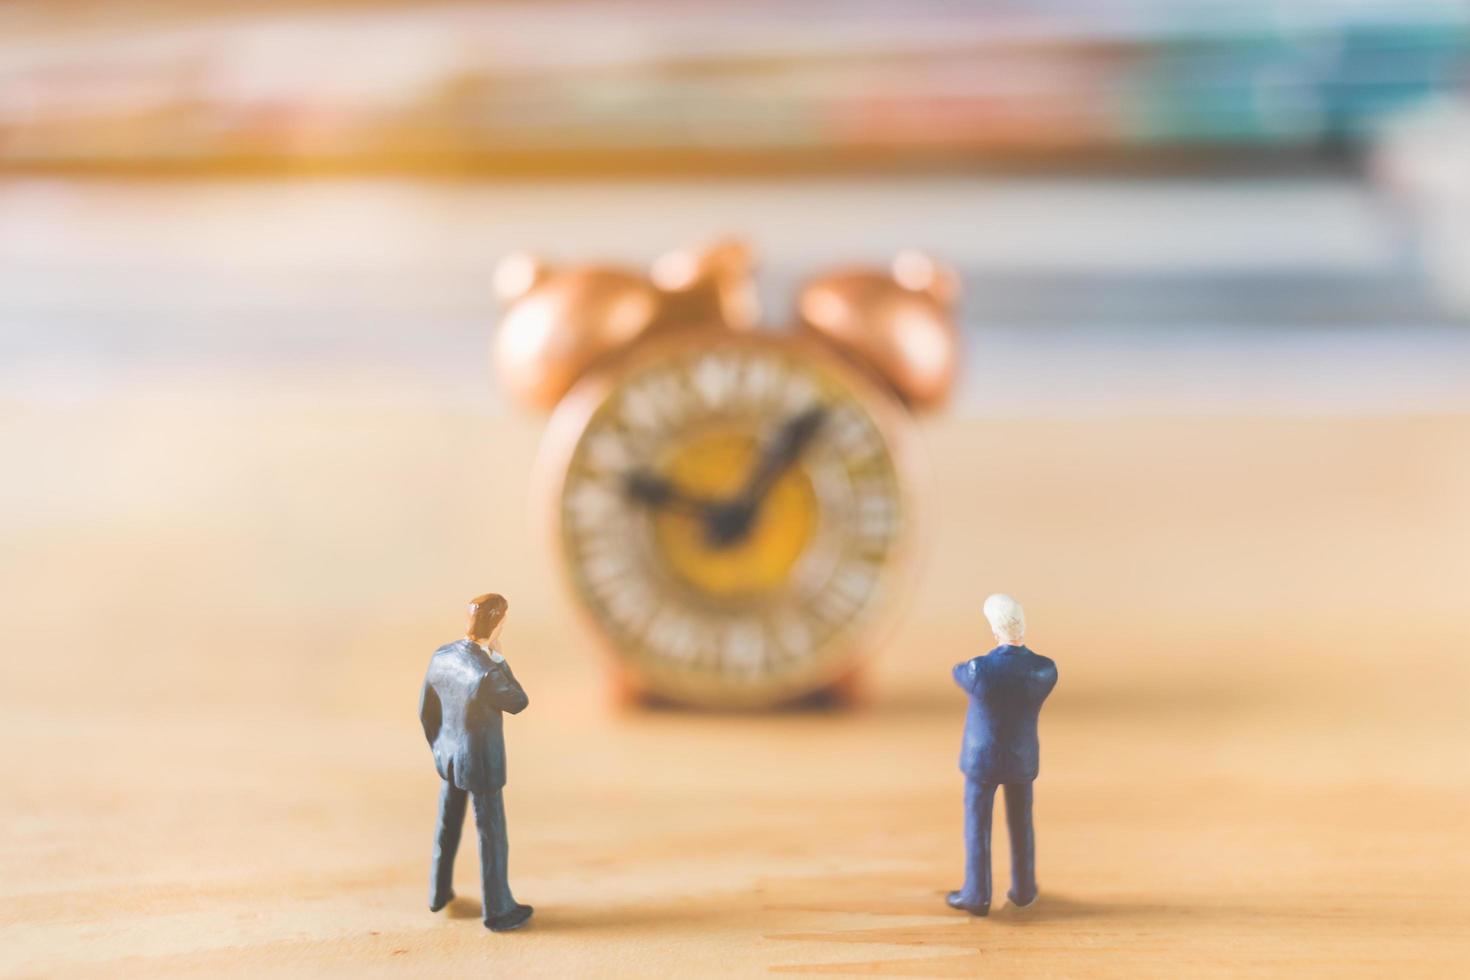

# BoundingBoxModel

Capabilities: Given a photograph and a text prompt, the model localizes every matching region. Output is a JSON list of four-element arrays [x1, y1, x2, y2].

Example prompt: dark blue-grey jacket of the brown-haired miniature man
[[419, 639, 529, 792]]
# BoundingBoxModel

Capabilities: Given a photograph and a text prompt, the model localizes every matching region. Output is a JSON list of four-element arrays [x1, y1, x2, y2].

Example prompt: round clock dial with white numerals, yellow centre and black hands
[[553, 334, 910, 707]]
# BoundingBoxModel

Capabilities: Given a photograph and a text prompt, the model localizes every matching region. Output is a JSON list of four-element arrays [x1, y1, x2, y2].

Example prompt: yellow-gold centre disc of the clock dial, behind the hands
[[654, 430, 817, 598]]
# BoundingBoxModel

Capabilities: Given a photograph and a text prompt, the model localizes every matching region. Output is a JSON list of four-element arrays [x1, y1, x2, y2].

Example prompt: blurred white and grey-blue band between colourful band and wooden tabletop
[[0, 178, 1470, 416]]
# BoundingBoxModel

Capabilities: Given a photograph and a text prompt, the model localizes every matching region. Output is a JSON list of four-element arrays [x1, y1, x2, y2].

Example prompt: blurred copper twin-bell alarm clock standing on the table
[[494, 244, 957, 708]]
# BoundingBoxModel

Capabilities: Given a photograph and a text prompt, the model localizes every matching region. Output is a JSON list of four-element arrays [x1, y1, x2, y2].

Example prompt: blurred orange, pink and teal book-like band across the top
[[0, 0, 1470, 172]]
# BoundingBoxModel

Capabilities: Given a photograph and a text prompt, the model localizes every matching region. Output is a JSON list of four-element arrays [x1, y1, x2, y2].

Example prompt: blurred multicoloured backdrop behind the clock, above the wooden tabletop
[[0, 0, 1470, 413]]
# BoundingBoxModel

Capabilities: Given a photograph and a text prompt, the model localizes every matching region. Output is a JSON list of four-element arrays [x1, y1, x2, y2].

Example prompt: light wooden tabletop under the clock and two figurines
[[0, 379, 1470, 977]]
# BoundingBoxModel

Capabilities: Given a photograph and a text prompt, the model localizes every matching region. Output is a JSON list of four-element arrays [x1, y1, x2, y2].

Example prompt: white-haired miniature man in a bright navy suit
[[948, 595, 1057, 915]]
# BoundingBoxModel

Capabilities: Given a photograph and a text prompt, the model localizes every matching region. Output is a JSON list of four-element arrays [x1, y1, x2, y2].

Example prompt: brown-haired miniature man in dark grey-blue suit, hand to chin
[[419, 594, 532, 933]]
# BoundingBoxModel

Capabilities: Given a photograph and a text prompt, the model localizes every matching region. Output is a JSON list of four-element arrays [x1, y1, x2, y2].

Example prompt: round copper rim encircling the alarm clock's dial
[[532, 326, 928, 711]]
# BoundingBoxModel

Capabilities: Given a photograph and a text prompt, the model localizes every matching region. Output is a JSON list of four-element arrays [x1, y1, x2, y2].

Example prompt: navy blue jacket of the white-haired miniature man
[[954, 644, 1057, 783]]
